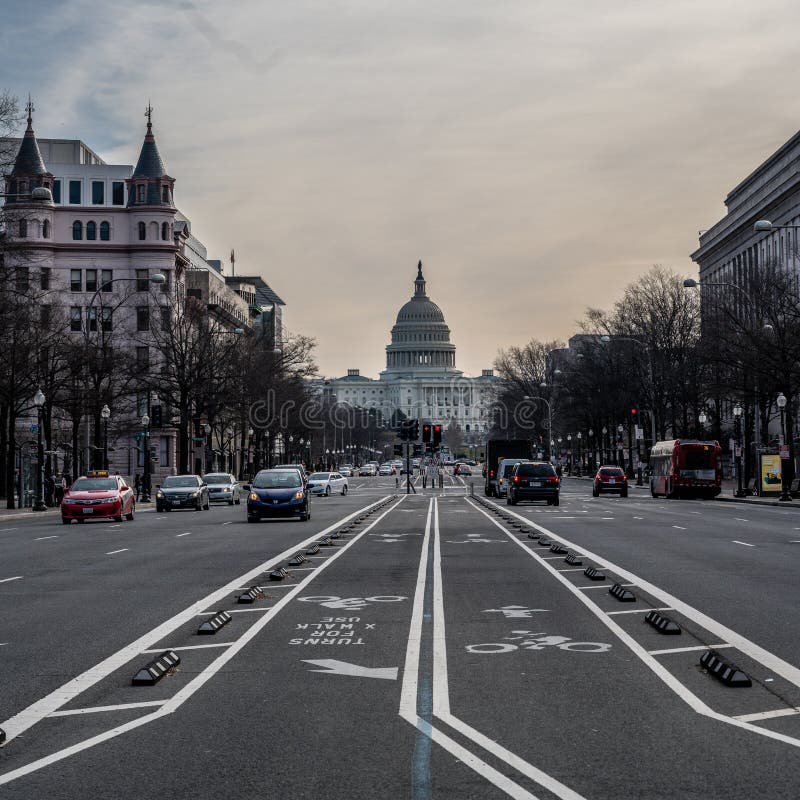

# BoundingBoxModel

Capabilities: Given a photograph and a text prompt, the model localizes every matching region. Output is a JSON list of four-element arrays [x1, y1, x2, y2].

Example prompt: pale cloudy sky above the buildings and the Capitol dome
[[0, 0, 800, 377]]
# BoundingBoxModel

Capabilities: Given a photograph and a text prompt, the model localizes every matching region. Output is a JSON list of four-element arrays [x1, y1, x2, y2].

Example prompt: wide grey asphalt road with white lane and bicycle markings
[[0, 477, 800, 800]]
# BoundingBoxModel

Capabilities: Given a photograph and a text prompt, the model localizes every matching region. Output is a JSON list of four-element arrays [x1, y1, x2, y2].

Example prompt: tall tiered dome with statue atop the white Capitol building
[[382, 261, 461, 378]]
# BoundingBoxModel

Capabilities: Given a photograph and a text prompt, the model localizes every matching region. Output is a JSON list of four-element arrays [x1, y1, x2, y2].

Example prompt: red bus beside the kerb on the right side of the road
[[650, 439, 722, 497]]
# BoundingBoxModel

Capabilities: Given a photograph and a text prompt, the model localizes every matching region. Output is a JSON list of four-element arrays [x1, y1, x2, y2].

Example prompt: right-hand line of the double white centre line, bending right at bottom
[[428, 501, 584, 800]]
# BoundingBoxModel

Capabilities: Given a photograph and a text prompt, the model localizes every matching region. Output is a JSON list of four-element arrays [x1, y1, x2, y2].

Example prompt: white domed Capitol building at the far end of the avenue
[[316, 262, 497, 439]]
